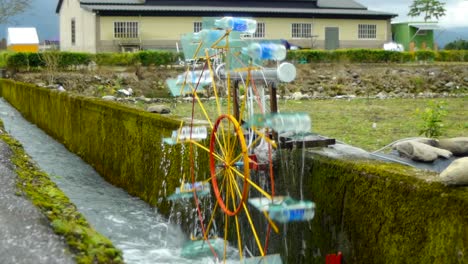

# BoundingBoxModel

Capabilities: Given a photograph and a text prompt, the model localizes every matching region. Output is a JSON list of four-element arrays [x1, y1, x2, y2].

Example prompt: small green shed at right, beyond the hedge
[[392, 22, 439, 51]]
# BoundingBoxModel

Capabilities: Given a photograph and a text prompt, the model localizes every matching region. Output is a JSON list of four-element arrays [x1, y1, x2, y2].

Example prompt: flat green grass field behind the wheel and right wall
[[173, 96, 468, 151]]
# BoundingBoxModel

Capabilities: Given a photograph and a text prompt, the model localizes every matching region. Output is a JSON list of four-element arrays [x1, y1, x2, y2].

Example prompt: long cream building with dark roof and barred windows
[[56, 0, 396, 52]]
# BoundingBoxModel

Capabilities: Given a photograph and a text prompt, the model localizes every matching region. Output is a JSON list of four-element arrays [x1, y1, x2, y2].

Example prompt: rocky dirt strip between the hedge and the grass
[[12, 64, 468, 98]]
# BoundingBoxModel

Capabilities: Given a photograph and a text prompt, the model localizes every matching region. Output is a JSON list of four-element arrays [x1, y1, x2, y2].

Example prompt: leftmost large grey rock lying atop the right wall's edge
[[393, 140, 452, 162]]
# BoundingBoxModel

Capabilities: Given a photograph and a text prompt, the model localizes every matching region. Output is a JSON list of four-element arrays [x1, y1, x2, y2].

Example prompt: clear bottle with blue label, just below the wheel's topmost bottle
[[242, 43, 286, 61]]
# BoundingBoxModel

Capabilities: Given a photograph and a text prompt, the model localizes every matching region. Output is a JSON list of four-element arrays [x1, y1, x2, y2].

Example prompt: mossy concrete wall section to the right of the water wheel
[[272, 151, 468, 264]]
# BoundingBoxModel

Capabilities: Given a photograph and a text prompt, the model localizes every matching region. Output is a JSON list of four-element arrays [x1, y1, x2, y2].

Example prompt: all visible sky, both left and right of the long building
[[0, 0, 468, 41]]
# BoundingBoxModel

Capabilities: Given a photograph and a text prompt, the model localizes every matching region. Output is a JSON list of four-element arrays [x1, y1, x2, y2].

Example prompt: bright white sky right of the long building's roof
[[356, 0, 468, 28]]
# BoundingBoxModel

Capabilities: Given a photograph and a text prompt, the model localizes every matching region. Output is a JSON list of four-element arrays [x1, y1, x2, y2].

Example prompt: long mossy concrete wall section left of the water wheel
[[0, 80, 206, 213]]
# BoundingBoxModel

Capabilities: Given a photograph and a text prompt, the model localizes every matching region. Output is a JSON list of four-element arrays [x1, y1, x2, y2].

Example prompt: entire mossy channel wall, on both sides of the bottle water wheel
[[0, 80, 468, 263]]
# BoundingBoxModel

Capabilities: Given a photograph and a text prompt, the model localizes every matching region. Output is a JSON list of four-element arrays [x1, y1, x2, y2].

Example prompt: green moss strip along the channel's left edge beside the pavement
[[0, 122, 123, 264]]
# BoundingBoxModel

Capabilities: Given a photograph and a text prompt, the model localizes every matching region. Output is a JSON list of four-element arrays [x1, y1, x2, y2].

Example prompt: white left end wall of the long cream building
[[59, 0, 96, 53]]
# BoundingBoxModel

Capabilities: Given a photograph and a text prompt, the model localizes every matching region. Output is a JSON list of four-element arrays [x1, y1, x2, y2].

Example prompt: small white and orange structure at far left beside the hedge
[[7, 27, 39, 52]]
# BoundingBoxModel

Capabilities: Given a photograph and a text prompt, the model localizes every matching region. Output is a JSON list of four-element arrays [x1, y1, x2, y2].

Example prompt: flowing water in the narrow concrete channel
[[0, 98, 232, 264]]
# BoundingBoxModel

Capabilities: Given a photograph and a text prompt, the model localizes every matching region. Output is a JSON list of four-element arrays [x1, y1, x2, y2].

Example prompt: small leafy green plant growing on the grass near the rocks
[[416, 100, 447, 138]]
